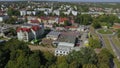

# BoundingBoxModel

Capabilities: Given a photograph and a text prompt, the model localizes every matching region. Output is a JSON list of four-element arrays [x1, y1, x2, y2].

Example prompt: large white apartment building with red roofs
[[17, 24, 44, 42]]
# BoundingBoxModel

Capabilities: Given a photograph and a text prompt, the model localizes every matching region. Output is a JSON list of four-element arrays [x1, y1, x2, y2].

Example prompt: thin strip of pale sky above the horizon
[[0, 0, 120, 2]]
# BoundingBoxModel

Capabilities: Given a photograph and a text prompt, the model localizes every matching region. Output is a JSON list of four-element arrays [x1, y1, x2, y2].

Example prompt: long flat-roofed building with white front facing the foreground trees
[[55, 32, 78, 56]]
